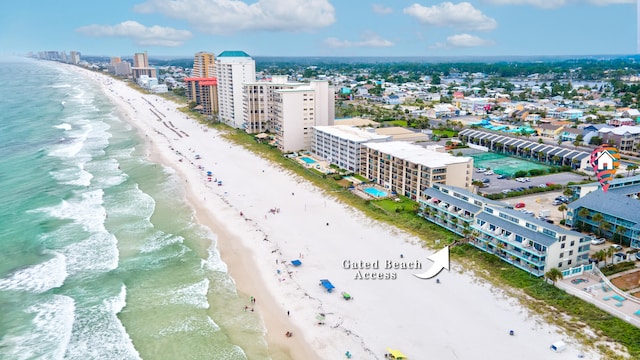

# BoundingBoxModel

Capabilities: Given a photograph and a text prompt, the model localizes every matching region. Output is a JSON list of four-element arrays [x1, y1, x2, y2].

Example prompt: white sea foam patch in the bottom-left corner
[[0, 295, 75, 360]]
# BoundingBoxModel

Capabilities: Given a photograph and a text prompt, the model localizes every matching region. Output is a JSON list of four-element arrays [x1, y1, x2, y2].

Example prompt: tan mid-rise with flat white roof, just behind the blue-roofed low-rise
[[360, 141, 473, 200]]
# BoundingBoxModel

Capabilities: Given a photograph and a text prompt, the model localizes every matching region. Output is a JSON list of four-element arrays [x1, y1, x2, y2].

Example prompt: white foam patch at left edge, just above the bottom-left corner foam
[[0, 252, 67, 293]]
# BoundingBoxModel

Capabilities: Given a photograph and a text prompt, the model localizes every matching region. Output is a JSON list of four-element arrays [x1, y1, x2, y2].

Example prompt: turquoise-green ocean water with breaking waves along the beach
[[0, 58, 269, 360]]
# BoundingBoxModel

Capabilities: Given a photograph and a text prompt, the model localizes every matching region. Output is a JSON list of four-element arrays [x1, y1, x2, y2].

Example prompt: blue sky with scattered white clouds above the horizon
[[0, 0, 639, 57]]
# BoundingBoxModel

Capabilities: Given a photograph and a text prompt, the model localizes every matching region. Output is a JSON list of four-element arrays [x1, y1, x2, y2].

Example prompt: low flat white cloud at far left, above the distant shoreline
[[76, 21, 191, 47]]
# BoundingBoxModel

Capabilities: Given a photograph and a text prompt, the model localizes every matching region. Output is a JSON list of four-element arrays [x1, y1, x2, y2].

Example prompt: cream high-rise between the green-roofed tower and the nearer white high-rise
[[243, 75, 305, 134]]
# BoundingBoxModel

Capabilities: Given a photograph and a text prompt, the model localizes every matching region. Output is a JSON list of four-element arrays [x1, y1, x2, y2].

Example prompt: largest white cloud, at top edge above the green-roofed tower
[[134, 0, 335, 34]]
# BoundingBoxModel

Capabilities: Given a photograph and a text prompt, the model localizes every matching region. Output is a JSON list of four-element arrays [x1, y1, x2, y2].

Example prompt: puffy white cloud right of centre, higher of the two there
[[403, 2, 498, 31]]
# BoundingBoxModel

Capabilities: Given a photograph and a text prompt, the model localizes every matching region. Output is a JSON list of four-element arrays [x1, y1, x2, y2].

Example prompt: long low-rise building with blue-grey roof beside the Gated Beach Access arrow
[[418, 184, 591, 276]]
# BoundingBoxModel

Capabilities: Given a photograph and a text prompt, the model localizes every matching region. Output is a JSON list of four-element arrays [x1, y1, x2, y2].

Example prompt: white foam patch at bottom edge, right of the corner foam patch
[[65, 285, 140, 360]]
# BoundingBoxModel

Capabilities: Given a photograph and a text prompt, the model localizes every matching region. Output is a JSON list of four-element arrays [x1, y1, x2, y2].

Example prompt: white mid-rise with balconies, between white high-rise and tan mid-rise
[[311, 125, 393, 173]]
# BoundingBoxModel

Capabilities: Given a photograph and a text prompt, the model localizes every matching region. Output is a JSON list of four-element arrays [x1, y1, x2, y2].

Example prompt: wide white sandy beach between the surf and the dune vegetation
[[74, 67, 600, 360]]
